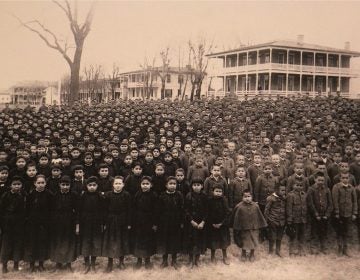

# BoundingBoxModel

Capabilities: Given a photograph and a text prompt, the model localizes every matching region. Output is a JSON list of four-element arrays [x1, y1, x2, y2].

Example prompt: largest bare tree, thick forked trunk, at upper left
[[17, 0, 94, 105]]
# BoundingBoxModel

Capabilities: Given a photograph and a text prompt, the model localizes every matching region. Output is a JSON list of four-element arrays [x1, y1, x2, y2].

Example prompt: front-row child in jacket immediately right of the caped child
[[264, 186, 286, 257]]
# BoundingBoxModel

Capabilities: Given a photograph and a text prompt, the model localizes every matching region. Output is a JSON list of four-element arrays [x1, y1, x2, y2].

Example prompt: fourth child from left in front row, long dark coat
[[79, 177, 104, 273]]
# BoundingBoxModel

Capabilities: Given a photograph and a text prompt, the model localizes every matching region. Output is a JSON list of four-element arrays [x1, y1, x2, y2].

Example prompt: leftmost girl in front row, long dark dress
[[0, 176, 25, 273]]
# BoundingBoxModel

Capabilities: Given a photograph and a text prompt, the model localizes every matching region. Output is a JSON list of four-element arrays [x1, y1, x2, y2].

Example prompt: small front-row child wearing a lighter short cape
[[232, 190, 267, 262]]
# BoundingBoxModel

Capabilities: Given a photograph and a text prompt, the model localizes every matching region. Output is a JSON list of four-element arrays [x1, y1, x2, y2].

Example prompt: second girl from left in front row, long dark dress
[[24, 175, 53, 272]]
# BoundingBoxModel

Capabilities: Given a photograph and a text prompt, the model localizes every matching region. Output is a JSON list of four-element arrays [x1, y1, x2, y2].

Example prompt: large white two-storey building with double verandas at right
[[207, 35, 360, 98]]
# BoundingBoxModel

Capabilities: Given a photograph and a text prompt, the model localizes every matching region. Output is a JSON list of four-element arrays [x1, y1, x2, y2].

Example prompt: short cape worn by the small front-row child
[[231, 201, 267, 231]]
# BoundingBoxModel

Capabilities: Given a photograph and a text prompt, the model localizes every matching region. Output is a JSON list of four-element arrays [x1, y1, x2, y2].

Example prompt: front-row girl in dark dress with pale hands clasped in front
[[184, 179, 208, 267]]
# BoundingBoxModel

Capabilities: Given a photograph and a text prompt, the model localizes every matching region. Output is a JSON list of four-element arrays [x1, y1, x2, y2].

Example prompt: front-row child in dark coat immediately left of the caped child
[[206, 185, 230, 265]]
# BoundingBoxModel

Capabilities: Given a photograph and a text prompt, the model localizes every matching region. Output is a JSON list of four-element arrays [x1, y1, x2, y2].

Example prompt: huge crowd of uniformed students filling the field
[[0, 97, 360, 273]]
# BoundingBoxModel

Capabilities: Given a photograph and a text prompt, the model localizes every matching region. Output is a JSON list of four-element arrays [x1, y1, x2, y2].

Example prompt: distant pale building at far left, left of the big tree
[[9, 81, 61, 106]]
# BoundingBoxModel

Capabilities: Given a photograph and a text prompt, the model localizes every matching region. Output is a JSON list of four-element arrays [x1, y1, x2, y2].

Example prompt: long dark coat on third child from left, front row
[[50, 191, 78, 263]]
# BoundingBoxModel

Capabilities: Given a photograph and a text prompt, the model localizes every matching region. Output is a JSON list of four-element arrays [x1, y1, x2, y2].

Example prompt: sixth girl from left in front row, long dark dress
[[134, 176, 158, 268]]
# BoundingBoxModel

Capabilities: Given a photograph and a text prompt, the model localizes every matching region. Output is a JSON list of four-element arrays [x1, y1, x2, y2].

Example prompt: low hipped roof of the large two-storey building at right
[[206, 40, 360, 56]]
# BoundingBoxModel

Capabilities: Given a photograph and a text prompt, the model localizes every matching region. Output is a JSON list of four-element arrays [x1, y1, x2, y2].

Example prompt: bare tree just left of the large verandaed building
[[188, 39, 212, 100]]
